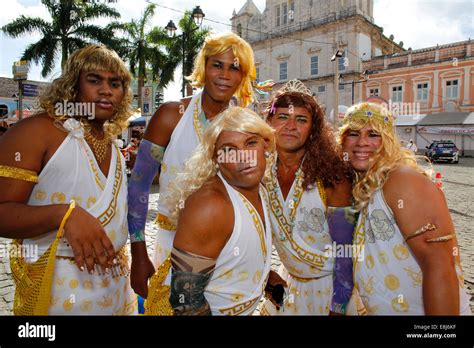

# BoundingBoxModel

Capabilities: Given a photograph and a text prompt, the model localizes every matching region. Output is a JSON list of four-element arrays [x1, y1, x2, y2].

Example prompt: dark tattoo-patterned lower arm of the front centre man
[[170, 247, 216, 315]]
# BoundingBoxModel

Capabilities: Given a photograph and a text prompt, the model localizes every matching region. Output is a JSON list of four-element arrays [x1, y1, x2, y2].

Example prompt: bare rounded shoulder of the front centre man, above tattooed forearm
[[175, 177, 234, 258]]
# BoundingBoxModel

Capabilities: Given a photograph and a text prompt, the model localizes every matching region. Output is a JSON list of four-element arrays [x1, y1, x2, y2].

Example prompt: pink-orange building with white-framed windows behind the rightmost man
[[360, 40, 474, 155]]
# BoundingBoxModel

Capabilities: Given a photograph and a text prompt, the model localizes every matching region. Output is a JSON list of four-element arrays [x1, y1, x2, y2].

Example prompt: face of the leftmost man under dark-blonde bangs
[[76, 71, 124, 121]]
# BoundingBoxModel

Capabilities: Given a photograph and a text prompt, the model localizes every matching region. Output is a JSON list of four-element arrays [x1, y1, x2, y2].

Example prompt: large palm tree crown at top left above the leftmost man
[[1, 0, 120, 77]]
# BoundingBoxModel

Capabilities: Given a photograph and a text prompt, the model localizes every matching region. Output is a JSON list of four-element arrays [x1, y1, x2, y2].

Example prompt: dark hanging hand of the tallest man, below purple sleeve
[[130, 242, 155, 298]]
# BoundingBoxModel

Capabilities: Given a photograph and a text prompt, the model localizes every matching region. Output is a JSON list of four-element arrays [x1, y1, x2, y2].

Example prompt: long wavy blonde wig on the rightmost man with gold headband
[[339, 103, 429, 209]]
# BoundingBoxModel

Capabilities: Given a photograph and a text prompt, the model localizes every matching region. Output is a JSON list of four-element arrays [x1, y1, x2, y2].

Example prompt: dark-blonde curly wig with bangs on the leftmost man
[[39, 45, 133, 137]]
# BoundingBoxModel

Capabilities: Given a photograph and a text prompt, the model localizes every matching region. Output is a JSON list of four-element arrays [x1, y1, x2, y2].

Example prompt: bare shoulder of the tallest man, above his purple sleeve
[[144, 99, 189, 147]]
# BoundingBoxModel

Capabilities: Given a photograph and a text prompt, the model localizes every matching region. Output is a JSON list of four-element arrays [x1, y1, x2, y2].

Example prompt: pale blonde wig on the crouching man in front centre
[[165, 106, 275, 225]]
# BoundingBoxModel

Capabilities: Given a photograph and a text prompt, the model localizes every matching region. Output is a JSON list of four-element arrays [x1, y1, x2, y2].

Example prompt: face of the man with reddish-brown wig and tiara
[[269, 106, 313, 152]]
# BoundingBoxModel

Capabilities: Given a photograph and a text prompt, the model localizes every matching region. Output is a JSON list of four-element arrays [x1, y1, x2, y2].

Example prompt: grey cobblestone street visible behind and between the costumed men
[[0, 158, 474, 315]]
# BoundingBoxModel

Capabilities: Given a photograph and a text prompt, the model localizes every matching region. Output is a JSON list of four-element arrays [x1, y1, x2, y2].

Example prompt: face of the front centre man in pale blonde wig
[[215, 131, 266, 189]]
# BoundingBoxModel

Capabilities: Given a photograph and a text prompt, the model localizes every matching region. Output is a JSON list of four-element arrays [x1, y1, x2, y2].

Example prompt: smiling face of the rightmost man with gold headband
[[342, 125, 382, 171]]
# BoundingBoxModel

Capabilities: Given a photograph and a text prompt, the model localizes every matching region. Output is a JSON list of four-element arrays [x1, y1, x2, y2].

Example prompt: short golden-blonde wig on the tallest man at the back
[[187, 33, 257, 107]]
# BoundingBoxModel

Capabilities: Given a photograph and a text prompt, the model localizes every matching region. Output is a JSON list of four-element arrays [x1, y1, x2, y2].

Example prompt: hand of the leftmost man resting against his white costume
[[64, 207, 115, 274]]
